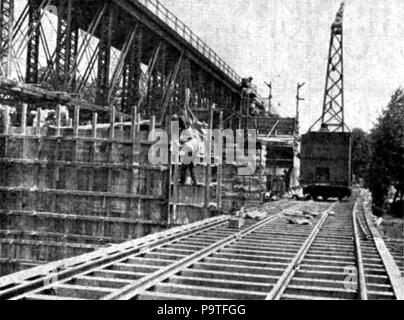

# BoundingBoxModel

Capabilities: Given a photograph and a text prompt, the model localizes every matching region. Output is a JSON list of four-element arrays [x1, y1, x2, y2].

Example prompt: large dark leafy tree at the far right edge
[[370, 88, 404, 215]]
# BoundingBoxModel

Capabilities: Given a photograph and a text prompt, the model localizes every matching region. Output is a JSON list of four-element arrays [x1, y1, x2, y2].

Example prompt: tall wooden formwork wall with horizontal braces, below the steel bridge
[[0, 107, 221, 274]]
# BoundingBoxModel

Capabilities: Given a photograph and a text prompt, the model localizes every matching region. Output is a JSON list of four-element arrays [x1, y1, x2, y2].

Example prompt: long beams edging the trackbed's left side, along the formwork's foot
[[0, 201, 294, 300]]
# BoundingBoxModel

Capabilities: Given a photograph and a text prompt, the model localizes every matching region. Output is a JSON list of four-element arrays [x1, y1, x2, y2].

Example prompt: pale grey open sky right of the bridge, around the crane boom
[[160, 0, 404, 131]]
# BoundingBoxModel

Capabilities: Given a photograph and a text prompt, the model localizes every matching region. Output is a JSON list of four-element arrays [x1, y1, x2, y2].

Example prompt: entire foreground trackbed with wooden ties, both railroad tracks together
[[0, 192, 403, 300]]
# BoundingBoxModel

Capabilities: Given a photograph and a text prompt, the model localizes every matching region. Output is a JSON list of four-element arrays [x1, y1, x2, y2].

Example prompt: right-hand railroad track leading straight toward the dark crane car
[[274, 192, 404, 300]]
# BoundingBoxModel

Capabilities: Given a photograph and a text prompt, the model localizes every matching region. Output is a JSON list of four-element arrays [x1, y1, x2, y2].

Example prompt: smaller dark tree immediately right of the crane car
[[352, 129, 370, 186]]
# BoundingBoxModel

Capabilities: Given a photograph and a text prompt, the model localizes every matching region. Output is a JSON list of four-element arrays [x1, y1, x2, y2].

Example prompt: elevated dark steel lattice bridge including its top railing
[[0, 0, 266, 126]]
